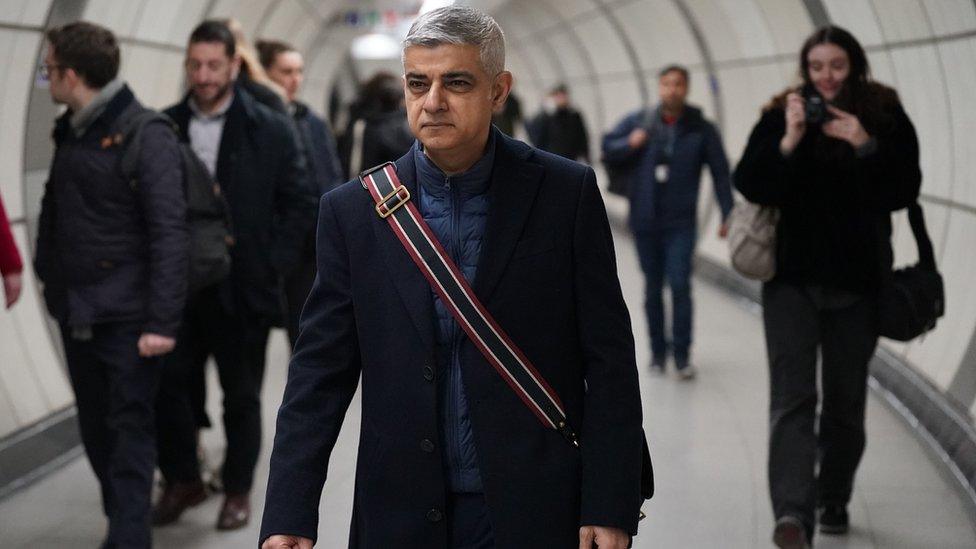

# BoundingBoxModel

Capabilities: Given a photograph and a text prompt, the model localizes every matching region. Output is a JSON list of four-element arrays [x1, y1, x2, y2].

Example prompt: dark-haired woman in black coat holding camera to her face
[[735, 26, 922, 548]]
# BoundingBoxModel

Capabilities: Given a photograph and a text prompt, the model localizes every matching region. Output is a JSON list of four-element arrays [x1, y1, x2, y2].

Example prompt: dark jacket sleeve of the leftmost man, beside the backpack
[[137, 123, 190, 337]]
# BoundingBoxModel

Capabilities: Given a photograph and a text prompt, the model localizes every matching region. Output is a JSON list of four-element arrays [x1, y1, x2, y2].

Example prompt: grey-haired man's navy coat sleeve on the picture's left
[[261, 193, 361, 541]]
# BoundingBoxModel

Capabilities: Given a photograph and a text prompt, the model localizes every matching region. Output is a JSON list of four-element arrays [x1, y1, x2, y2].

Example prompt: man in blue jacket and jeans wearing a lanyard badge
[[603, 65, 732, 379]]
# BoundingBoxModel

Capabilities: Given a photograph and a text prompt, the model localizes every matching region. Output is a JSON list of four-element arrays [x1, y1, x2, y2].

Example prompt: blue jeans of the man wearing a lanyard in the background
[[634, 227, 697, 368]]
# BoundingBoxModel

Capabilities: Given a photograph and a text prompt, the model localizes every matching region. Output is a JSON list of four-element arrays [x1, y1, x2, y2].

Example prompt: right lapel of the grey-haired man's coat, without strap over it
[[474, 132, 542, 303]]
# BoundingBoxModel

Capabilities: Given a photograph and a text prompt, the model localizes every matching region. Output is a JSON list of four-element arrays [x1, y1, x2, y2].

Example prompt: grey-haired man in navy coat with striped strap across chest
[[261, 7, 645, 549]]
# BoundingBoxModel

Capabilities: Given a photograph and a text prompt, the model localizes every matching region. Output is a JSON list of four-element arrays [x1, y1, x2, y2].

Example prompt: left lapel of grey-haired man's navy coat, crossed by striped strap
[[372, 149, 435, 350]]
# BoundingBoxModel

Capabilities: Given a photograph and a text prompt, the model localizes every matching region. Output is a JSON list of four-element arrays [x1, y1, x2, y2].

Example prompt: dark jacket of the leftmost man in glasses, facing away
[[35, 87, 189, 337]]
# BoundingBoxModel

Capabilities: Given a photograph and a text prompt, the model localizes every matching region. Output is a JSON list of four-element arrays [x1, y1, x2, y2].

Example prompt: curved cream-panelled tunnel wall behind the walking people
[[0, 0, 976, 500]]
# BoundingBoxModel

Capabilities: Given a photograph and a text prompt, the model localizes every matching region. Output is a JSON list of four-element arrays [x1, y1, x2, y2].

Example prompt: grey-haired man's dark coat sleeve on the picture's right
[[573, 169, 643, 534]]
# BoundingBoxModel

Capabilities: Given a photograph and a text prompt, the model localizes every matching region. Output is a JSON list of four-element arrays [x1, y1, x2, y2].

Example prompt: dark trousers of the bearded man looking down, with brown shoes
[[157, 288, 270, 494]]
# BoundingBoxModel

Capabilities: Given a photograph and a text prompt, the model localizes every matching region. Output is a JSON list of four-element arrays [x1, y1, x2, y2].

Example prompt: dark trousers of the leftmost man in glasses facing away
[[61, 323, 160, 548]]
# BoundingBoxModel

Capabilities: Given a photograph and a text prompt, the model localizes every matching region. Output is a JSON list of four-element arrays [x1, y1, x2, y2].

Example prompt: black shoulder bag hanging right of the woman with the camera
[[878, 203, 945, 341]]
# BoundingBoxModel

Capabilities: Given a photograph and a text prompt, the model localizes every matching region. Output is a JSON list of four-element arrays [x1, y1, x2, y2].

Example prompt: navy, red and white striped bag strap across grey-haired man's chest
[[359, 162, 579, 446]]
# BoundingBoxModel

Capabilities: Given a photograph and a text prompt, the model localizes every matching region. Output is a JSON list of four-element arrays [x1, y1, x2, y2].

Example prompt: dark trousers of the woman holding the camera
[[762, 281, 878, 531]]
